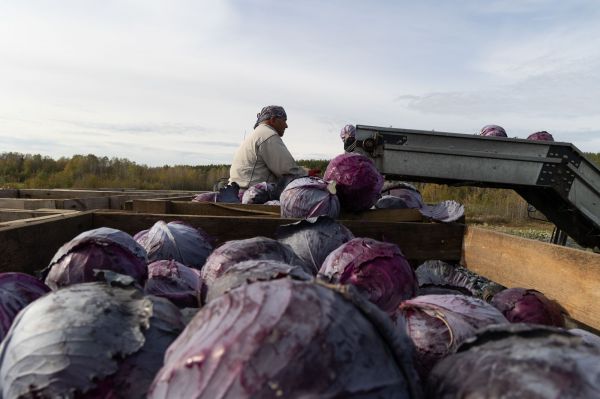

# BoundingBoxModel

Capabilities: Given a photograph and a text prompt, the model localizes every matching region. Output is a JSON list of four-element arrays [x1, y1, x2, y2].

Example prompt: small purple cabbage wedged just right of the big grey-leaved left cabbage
[[144, 260, 202, 308]]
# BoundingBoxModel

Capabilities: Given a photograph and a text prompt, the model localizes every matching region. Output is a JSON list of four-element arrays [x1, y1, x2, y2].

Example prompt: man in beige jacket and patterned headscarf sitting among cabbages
[[229, 105, 307, 190]]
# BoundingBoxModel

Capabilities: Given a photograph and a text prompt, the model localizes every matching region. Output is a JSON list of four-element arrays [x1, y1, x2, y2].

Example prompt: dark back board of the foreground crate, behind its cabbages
[[94, 211, 464, 266]]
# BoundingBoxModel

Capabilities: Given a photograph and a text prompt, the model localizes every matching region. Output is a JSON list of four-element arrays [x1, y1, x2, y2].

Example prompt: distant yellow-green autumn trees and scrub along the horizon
[[0, 152, 600, 223]]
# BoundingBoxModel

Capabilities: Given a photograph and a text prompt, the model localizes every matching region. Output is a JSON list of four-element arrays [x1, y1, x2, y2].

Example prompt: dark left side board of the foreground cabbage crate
[[0, 212, 93, 274]]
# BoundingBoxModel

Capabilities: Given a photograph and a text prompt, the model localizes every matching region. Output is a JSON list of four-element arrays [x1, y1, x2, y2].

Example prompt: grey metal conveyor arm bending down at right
[[356, 125, 600, 248]]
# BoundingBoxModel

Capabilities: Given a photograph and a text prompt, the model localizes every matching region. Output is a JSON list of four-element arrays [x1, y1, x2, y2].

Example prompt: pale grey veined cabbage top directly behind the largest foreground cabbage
[[206, 259, 312, 302]]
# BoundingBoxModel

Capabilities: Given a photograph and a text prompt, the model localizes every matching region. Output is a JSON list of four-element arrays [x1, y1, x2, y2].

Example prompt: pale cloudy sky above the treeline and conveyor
[[0, 0, 600, 166]]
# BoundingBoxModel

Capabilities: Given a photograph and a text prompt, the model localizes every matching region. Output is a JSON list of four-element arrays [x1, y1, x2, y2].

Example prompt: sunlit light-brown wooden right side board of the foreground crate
[[462, 227, 600, 330]]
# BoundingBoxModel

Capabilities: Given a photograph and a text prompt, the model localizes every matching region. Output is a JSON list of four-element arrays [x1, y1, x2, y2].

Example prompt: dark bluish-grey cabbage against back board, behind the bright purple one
[[276, 216, 354, 275]]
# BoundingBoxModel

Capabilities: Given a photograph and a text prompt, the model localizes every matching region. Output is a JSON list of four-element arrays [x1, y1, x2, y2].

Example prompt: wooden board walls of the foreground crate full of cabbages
[[0, 211, 600, 332]]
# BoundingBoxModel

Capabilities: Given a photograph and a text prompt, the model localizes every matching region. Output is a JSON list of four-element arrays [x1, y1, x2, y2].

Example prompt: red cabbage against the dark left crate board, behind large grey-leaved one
[[42, 227, 148, 290]]
